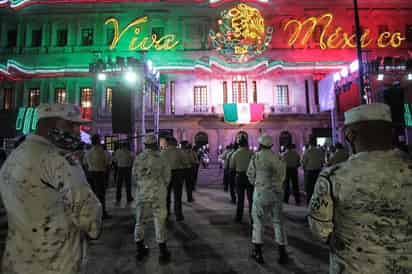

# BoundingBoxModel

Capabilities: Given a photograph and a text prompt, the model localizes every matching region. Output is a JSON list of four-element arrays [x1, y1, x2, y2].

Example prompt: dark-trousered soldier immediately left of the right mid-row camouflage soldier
[[229, 136, 253, 223]]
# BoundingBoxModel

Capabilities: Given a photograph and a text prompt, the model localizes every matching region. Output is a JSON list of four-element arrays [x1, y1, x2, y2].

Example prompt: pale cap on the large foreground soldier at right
[[345, 103, 392, 126]]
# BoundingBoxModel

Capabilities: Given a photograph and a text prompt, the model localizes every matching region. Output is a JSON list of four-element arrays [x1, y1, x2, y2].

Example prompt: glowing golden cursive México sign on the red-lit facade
[[283, 13, 406, 49]]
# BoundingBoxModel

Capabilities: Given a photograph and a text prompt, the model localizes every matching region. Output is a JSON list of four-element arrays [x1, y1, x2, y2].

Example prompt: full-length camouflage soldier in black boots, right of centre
[[247, 135, 288, 264]]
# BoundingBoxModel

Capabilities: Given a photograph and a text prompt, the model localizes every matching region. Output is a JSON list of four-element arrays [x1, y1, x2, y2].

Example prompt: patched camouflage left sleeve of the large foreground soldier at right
[[308, 175, 334, 243]]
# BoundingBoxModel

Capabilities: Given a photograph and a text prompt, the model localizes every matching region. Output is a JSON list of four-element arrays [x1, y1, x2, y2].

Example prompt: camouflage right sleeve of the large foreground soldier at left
[[47, 156, 102, 239]]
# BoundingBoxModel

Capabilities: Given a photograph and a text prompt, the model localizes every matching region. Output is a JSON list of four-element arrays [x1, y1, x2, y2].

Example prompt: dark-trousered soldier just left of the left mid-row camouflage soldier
[[113, 143, 133, 204]]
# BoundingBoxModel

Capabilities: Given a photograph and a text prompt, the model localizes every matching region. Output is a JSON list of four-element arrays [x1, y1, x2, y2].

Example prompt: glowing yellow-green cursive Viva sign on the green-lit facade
[[104, 16, 179, 50]]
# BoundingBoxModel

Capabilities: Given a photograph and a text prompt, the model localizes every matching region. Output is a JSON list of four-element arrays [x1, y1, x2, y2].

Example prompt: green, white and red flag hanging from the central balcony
[[223, 104, 264, 124]]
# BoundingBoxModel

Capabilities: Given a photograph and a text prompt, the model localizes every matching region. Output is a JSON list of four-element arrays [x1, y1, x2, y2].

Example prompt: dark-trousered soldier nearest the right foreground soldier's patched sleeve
[[302, 137, 325, 204]]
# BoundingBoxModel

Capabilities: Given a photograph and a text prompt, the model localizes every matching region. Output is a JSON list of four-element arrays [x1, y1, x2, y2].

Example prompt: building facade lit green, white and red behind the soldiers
[[0, 0, 412, 155]]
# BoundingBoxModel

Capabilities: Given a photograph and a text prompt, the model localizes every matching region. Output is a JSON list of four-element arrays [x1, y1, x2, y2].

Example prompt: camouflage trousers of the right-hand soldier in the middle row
[[252, 192, 287, 245]]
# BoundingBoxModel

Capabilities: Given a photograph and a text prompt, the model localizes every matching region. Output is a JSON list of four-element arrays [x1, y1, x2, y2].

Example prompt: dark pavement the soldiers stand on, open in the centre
[[0, 166, 328, 274]]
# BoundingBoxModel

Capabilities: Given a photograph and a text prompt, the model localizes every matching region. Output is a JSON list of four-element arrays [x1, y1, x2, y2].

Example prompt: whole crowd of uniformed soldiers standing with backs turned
[[0, 104, 412, 274]]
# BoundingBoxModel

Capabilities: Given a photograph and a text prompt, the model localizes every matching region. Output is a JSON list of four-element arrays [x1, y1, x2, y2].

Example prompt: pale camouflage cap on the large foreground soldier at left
[[36, 104, 90, 124]]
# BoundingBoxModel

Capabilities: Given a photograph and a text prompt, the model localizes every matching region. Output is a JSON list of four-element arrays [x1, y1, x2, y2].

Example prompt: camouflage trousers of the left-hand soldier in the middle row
[[134, 200, 167, 243]]
